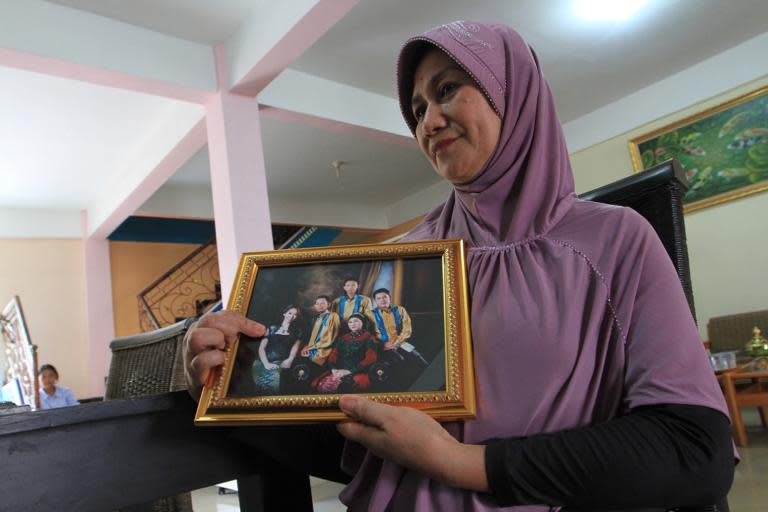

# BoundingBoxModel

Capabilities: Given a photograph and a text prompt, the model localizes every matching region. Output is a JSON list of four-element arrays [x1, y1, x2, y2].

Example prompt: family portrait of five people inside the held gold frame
[[227, 257, 445, 397]]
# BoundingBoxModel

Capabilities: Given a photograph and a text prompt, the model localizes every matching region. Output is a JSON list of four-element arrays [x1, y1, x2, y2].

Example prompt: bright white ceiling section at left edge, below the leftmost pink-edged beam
[[0, 67, 203, 209]]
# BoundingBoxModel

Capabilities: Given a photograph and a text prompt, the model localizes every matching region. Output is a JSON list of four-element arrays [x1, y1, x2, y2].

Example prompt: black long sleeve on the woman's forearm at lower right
[[485, 405, 734, 509]]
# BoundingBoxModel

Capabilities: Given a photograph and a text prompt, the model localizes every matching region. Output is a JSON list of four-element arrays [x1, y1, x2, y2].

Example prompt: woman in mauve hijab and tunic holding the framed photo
[[184, 22, 733, 511]]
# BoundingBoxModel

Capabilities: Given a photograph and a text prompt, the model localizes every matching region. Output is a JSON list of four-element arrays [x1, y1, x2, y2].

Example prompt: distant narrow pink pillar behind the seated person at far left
[[81, 211, 115, 396]]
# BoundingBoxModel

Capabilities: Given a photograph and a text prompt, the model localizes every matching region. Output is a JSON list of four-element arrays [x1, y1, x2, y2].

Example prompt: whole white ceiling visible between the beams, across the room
[[0, 0, 768, 232]]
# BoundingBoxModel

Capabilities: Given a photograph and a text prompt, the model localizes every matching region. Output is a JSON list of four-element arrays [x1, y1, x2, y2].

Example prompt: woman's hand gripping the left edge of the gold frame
[[184, 310, 266, 400]]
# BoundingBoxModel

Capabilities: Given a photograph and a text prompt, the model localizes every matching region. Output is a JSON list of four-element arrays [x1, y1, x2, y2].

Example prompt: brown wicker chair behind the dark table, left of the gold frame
[[104, 319, 193, 512]]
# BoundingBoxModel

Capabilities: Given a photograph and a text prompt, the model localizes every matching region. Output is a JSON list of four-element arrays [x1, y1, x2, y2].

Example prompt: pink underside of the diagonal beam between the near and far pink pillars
[[92, 119, 208, 238]]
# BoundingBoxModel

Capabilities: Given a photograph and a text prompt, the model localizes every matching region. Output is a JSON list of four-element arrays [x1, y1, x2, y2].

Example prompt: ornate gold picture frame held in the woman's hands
[[195, 240, 476, 426]]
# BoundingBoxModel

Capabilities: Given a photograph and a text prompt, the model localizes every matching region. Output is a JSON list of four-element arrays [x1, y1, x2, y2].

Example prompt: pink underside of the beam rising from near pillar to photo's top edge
[[232, 0, 359, 96]]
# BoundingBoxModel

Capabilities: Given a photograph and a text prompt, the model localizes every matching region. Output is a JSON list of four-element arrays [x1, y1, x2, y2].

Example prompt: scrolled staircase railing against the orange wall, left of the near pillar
[[137, 242, 221, 332]]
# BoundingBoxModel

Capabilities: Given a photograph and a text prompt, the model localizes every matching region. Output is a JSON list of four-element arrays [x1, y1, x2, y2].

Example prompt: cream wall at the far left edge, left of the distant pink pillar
[[0, 238, 89, 398]]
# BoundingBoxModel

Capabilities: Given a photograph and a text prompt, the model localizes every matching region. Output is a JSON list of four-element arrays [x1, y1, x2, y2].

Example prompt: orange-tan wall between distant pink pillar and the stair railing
[[109, 242, 199, 337]]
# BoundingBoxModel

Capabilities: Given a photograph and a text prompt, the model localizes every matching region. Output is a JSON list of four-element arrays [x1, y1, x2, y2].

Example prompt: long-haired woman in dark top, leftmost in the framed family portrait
[[253, 304, 302, 395]]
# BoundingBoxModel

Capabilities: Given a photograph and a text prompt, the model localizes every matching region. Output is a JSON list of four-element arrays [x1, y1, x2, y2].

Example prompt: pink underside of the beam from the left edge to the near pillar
[[0, 48, 212, 104]]
